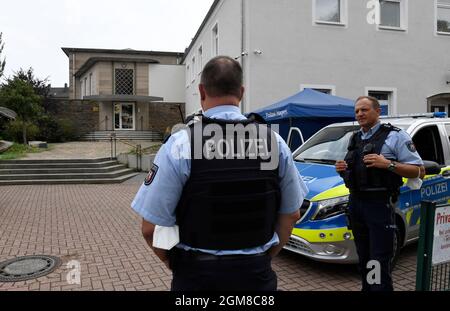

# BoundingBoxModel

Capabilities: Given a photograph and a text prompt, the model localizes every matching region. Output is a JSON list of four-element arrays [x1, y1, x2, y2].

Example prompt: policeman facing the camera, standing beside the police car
[[336, 96, 425, 291]]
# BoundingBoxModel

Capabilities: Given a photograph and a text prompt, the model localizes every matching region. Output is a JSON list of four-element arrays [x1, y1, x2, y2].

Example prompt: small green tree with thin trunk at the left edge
[[0, 77, 42, 144]]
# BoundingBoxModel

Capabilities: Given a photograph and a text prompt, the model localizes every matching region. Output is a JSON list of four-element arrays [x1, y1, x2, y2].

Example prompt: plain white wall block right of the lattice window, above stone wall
[[148, 64, 185, 103]]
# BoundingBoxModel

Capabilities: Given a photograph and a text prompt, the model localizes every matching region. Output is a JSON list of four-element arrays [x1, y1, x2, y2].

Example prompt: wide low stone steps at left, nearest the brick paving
[[0, 158, 138, 186]]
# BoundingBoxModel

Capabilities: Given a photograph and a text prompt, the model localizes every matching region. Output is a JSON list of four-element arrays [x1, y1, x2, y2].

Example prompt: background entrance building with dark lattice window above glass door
[[62, 48, 185, 132]]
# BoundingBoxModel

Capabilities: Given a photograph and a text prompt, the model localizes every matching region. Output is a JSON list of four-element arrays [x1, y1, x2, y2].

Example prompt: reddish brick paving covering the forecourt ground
[[0, 174, 416, 291]]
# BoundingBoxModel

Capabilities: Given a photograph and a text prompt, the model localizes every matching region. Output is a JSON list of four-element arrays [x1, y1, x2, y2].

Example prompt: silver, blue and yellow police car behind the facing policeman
[[285, 113, 450, 263]]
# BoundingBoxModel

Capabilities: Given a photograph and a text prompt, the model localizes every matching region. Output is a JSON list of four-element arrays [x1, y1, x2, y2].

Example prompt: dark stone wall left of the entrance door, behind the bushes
[[46, 100, 99, 136]]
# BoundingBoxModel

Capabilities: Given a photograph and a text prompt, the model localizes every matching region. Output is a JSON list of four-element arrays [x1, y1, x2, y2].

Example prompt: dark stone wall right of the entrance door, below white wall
[[149, 102, 186, 134]]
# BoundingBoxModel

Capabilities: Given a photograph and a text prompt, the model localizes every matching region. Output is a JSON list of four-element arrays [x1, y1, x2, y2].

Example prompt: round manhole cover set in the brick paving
[[0, 255, 61, 282]]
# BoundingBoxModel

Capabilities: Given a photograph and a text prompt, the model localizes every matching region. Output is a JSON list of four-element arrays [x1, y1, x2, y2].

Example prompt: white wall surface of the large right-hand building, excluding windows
[[185, 0, 450, 113]]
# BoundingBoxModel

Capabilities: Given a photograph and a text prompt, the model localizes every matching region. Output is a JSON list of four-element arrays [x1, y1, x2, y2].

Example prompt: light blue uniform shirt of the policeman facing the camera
[[360, 122, 423, 165]]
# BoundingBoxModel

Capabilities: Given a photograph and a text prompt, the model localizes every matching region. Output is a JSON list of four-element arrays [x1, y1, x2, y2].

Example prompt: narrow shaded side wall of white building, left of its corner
[[183, 0, 241, 115]]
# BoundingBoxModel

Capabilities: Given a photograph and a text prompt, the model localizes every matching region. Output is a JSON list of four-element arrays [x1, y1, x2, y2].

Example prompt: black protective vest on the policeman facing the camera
[[343, 124, 403, 193]]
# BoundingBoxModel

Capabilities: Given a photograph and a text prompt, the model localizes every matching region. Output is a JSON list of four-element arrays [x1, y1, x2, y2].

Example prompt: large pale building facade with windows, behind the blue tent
[[182, 0, 450, 114]]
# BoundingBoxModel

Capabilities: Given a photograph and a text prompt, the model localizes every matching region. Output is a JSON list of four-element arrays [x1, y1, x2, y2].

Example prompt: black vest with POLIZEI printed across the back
[[176, 117, 280, 250]]
